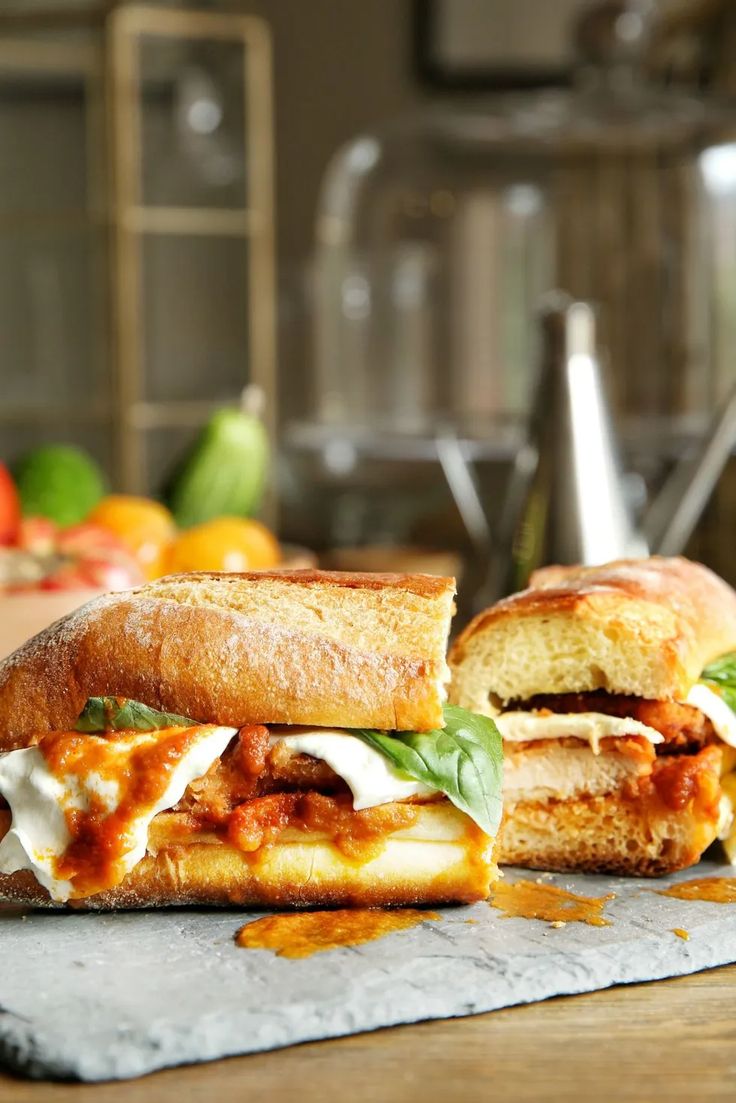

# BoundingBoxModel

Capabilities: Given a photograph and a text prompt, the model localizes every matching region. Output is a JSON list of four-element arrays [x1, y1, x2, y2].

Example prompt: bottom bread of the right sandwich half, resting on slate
[[495, 793, 718, 877]]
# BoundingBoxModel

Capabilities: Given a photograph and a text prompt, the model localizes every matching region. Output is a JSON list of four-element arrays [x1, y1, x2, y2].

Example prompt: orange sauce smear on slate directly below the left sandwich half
[[235, 908, 440, 957]]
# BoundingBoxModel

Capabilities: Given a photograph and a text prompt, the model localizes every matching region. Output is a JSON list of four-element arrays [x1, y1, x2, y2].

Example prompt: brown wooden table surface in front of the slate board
[[0, 966, 736, 1103]]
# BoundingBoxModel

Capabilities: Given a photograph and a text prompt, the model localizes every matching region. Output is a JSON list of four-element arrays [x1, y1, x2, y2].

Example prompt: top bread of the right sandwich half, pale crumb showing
[[449, 556, 736, 714]]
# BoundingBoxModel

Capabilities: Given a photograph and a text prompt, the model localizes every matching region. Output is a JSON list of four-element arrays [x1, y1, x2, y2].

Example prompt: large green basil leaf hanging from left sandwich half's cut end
[[351, 705, 503, 835]]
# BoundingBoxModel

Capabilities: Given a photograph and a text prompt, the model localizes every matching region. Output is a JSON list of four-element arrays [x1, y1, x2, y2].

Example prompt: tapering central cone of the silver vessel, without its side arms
[[497, 292, 648, 592]]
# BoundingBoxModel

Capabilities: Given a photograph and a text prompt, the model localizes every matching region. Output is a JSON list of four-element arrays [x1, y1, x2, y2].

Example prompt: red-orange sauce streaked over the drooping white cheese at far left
[[39, 727, 207, 899]]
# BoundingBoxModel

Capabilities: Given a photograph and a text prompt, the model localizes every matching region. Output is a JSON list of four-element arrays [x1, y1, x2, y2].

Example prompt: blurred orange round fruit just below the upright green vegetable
[[167, 517, 281, 574]]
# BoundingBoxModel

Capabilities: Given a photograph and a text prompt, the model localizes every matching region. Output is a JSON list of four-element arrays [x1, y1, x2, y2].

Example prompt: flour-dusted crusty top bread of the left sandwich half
[[0, 570, 455, 750]]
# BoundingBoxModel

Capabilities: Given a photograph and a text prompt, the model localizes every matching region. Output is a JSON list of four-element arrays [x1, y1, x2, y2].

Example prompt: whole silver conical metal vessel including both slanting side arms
[[437, 291, 736, 608]]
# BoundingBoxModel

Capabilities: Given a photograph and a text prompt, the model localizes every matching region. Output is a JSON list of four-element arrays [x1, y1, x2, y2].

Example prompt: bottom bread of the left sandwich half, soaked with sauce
[[0, 801, 498, 909]]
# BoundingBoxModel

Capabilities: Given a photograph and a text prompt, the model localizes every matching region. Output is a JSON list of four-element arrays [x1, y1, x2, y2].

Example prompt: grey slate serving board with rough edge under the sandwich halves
[[0, 863, 736, 1081]]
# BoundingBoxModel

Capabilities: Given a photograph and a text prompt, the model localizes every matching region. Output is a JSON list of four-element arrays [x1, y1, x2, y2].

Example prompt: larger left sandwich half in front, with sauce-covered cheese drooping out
[[0, 571, 502, 908]]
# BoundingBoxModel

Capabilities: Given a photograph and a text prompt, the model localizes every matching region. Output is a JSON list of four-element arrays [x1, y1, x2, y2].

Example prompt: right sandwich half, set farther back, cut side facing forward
[[449, 557, 736, 876]]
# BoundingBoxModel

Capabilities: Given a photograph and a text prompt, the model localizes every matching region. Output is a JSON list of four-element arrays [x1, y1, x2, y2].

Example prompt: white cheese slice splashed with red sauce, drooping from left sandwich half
[[0, 727, 237, 903]]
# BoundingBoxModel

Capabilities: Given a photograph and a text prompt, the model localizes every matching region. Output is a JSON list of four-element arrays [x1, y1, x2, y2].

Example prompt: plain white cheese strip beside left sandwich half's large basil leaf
[[271, 728, 437, 812]]
